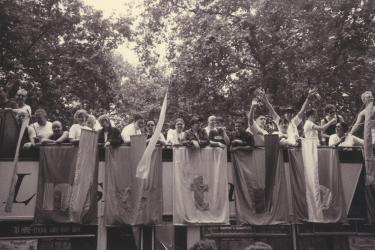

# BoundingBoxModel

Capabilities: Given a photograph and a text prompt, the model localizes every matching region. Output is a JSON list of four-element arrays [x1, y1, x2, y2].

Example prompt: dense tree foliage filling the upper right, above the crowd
[[135, 0, 375, 124]]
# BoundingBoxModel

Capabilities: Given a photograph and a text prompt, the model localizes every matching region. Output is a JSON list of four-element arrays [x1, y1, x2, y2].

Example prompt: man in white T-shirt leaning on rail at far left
[[28, 109, 53, 145]]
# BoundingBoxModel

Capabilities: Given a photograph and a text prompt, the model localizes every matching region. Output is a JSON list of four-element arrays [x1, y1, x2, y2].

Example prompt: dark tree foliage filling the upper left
[[0, 0, 130, 125]]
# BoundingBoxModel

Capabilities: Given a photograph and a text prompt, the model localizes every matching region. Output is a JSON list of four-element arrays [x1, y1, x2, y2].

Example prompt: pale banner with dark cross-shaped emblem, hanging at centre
[[173, 147, 229, 225]]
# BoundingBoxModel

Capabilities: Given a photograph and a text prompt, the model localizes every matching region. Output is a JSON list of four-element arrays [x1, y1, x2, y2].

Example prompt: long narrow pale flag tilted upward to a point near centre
[[136, 89, 168, 179]]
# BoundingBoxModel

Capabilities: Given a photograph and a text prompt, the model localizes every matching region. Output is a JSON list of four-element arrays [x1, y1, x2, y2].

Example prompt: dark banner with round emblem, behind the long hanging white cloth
[[288, 148, 347, 223]]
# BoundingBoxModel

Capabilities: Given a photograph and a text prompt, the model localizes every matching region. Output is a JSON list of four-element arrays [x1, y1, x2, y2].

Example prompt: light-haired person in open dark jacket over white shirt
[[98, 115, 122, 147]]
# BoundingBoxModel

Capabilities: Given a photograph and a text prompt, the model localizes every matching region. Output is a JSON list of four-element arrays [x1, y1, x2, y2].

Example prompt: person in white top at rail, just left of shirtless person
[[328, 122, 363, 147]]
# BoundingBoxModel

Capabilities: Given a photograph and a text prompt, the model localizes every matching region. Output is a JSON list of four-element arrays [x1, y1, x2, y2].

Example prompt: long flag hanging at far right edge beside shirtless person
[[363, 102, 375, 223]]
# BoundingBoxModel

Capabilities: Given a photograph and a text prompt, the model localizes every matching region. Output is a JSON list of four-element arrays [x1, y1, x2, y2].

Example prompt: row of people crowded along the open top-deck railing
[[0, 87, 375, 148]]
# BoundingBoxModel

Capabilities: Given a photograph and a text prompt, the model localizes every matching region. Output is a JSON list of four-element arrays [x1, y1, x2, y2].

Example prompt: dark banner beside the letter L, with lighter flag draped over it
[[35, 130, 98, 223]]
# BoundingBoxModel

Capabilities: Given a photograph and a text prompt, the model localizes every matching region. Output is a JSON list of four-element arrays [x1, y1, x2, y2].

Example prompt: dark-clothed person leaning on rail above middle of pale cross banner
[[182, 116, 209, 148]]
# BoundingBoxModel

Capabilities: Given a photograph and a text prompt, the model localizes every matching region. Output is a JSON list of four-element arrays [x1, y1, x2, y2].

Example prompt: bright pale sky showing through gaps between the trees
[[82, 0, 143, 65]]
